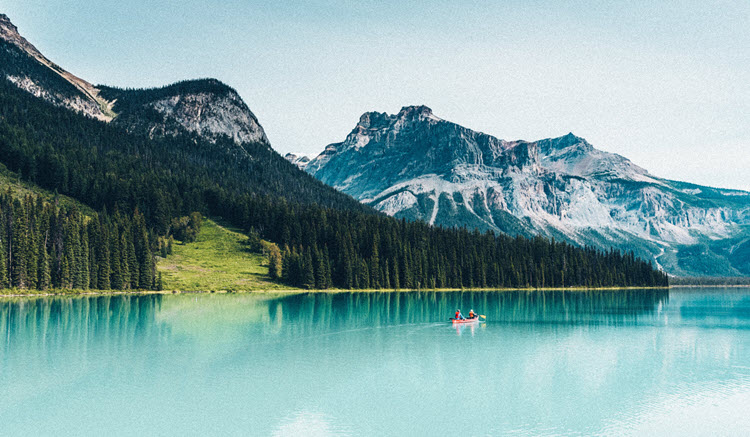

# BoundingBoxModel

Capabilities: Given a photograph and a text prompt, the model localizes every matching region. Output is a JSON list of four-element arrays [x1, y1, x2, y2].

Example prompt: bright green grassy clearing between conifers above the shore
[[156, 219, 296, 291]]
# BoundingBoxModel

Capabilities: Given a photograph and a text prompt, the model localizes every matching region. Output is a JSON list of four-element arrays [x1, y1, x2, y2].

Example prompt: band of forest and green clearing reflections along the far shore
[[0, 290, 668, 351]]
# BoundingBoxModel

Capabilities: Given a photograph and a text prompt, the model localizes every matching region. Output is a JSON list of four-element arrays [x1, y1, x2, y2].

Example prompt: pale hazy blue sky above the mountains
[[5, 0, 750, 190]]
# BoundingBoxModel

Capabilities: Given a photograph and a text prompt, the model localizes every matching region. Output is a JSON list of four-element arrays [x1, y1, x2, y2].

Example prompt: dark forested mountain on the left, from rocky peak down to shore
[[0, 13, 668, 289]]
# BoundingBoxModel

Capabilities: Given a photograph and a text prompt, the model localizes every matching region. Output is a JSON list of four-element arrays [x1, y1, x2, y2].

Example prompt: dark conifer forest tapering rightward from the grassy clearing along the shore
[[209, 193, 668, 289]]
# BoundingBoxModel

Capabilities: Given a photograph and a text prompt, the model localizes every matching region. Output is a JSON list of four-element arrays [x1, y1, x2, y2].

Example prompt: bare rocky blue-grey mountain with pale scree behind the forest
[[298, 106, 750, 276]]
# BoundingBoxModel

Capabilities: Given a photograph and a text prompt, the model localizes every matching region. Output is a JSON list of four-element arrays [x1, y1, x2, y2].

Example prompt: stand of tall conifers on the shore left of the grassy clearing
[[0, 191, 159, 290]]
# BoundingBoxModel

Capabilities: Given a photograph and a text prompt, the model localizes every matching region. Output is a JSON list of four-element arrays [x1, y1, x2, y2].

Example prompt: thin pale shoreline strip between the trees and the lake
[[0, 285, 676, 298]]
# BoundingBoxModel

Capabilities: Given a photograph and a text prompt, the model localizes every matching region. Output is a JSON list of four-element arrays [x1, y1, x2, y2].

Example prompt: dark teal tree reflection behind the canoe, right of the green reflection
[[269, 289, 669, 329]]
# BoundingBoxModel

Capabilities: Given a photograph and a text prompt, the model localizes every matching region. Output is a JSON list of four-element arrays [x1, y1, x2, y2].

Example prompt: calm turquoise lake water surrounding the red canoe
[[0, 288, 750, 436]]
